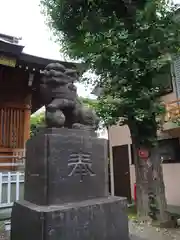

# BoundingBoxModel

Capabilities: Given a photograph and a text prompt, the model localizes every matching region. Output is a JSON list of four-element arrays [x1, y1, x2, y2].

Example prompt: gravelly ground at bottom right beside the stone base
[[129, 220, 180, 240]]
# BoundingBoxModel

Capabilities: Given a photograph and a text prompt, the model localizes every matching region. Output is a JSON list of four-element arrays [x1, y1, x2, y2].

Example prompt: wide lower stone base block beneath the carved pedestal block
[[11, 197, 129, 240]]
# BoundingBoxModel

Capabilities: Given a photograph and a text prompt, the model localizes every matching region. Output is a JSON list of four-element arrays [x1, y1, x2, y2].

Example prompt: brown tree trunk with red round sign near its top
[[134, 142, 169, 222]]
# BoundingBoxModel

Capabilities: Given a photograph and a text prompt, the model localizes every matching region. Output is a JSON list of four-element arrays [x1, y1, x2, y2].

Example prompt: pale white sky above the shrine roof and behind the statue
[[0, 0, 93, 97]]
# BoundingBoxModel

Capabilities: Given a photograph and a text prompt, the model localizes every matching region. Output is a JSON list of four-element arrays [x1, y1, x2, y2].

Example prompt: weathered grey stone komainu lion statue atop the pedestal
[[41, 63, 99, 130]]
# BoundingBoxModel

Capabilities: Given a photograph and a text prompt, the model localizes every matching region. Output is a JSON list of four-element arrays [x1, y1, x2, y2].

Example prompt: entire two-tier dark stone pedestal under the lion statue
[[11, 129, 129, 240]]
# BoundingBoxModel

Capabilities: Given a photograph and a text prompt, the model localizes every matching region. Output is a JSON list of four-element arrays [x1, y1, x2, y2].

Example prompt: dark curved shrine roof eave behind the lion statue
[[0, 33, 87, 113]]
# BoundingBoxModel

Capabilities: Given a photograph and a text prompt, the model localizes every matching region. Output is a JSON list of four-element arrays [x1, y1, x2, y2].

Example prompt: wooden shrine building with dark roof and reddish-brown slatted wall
[[0, 34, 80, 170]]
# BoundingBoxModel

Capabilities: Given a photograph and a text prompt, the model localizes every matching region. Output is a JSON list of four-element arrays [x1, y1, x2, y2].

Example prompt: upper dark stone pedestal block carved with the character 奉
[[24, 128, 108, 205]]
